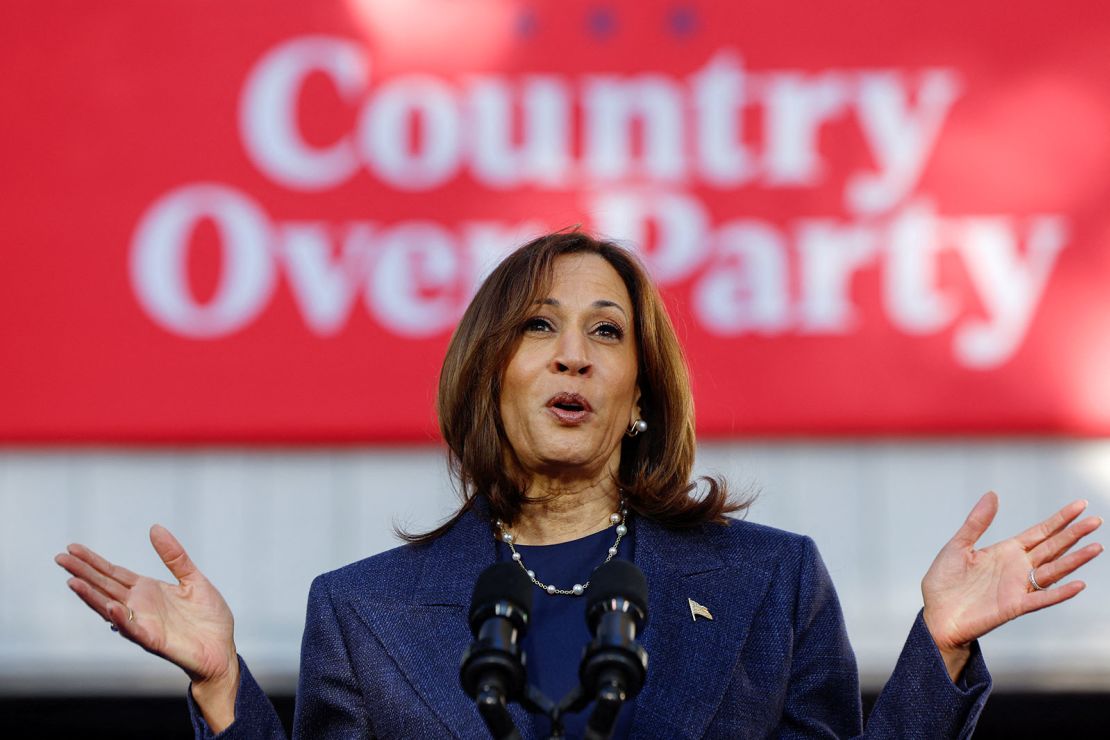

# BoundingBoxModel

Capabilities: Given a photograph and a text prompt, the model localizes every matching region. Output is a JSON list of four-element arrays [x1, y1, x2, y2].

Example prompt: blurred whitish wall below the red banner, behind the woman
[[0, 439, 1110, 693]]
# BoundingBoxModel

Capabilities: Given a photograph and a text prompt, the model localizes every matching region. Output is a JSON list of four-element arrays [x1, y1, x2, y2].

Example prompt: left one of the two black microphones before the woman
[[458, 562, 532, 738]]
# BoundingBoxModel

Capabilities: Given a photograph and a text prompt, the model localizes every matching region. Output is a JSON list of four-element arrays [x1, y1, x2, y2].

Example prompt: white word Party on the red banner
[[597, 188, 1067, 369]]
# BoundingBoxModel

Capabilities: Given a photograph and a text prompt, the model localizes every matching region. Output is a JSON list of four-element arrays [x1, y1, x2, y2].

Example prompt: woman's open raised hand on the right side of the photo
[[921, 491, 1102, 678]]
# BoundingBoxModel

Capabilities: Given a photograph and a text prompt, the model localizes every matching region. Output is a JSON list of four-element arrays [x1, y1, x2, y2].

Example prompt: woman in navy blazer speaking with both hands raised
[[57, 232, 1102, 738]]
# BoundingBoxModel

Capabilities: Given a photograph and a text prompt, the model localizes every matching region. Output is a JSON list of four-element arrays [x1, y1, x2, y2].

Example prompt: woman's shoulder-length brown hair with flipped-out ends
[[398, 231, 750, 543]]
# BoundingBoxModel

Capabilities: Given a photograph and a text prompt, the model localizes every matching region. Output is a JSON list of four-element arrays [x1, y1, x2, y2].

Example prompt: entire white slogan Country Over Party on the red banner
[[131, 36, 1068, 369]]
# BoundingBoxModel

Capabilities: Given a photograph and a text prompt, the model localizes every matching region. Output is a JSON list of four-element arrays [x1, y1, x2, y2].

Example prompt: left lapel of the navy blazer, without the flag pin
[[346, 499, 534, 740]]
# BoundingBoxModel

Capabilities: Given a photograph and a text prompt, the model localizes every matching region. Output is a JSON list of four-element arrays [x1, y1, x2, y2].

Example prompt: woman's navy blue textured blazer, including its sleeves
[[190, 506, 990, 740]]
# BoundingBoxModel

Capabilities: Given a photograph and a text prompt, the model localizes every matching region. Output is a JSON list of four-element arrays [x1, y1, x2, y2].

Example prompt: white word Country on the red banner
[[240, 37, 959, 207]]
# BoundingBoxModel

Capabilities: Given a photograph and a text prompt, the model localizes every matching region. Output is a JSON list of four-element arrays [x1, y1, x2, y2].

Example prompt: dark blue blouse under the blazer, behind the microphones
[[497, 517, 634, 738]]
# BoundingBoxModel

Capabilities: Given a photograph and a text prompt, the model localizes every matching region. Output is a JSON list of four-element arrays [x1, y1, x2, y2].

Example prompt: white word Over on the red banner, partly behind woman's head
[[131, 184, 545, 339]]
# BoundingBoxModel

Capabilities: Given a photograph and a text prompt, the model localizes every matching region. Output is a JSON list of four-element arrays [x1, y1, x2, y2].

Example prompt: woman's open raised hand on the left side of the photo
[[54, 525, 239, 731]]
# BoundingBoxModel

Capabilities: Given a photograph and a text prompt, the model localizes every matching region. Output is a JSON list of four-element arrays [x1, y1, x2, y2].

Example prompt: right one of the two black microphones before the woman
[[578, 560, 647, 738]]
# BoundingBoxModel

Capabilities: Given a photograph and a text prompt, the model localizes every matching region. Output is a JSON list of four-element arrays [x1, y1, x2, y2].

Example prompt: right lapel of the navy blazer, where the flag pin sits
[[632, 519, 770, 738]]
